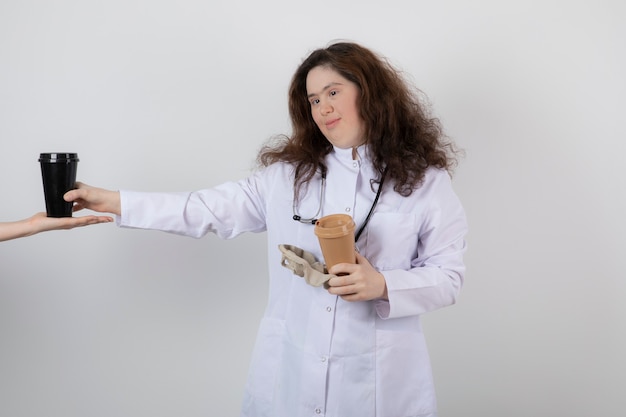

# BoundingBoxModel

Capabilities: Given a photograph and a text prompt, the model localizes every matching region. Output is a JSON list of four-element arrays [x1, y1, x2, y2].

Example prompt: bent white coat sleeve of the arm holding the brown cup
[[376, 174, 467, 319]]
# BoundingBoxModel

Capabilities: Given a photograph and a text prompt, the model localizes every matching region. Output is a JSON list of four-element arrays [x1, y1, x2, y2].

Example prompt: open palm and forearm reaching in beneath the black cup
[[0, 212, 113, 242]]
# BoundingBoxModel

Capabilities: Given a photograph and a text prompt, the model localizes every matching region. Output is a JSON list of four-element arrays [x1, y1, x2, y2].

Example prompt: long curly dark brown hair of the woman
[[257, 42, 459, 196]]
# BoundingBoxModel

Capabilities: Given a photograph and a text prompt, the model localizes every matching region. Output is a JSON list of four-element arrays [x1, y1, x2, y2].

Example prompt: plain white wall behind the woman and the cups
[[0, 0, 626, 417]]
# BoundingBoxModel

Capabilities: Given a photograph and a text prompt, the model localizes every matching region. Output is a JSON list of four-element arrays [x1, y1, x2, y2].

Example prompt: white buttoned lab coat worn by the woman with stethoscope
[[118, 147, 467, 417]]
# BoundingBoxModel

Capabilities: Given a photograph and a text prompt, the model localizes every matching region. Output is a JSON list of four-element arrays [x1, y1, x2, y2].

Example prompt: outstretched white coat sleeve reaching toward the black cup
[[117, 173, 266, 239]]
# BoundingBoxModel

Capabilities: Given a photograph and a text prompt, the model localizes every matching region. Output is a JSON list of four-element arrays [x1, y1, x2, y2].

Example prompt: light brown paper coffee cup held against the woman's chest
[[315, 214, 356, 270]]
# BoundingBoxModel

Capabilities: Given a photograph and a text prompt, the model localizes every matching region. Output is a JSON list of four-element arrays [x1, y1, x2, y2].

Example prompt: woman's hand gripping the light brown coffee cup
[[328, 252, 387, 301]]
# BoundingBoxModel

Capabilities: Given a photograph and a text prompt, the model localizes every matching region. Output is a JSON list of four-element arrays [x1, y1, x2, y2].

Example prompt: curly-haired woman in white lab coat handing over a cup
[[66, 43, 467, 417]]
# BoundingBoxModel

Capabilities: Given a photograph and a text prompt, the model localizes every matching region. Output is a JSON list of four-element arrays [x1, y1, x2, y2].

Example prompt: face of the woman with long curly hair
[[306, 66, 364, 149]]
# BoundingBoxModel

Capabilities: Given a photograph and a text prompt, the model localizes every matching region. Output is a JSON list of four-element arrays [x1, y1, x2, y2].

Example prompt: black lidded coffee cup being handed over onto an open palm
[[39, 152, 78, 217]]
